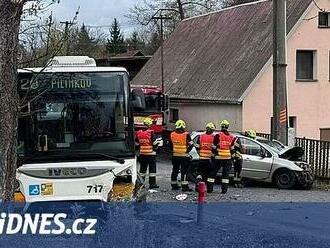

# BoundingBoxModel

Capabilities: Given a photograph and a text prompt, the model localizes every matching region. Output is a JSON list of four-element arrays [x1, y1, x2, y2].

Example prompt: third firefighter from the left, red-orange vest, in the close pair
[[195, 122, 215, 191]]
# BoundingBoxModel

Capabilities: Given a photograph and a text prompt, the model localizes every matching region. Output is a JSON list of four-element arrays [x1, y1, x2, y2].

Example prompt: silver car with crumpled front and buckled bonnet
[[189, 132, 313, 189]]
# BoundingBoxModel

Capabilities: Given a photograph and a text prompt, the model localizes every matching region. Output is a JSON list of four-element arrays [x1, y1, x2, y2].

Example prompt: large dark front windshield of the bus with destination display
[[19, 72, 134, 162]]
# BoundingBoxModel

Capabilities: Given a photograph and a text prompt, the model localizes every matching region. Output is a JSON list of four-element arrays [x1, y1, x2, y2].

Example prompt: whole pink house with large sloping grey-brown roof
[[132, 0, 330, 140]]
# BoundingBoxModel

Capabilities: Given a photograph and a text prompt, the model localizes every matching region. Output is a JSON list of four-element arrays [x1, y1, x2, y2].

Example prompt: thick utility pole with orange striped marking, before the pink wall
[[272, 0, 288, 144]]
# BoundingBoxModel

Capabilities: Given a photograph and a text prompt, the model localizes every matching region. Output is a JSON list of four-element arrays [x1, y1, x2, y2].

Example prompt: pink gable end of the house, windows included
[[242, 0, 330, 140]]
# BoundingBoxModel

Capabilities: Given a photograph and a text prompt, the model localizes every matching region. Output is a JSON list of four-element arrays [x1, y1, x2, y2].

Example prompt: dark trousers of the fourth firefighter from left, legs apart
[[207, 159, 232, 194]]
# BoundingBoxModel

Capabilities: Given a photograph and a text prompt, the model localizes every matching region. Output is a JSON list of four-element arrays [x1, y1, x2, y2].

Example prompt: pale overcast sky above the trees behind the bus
[[44, 0, 142, 34]]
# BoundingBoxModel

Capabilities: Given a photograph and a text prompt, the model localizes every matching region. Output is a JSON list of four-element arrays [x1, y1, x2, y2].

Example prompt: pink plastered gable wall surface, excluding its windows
[[243, 0, 330, 139]]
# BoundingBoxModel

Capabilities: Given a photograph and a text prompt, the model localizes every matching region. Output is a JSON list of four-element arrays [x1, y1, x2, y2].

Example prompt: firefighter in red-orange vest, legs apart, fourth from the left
[[207, 120, 234, 194]]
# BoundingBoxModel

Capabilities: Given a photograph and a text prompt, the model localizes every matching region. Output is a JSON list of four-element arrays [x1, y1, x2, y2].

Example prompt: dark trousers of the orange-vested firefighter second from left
[[171, 156, 190, 189]]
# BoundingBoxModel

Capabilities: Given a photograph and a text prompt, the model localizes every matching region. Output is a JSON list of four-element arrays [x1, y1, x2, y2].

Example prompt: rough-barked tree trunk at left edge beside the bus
[[0, 0, 59, 201]]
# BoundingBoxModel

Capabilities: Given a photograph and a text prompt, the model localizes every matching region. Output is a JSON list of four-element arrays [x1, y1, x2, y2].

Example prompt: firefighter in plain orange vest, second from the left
[[170, 120, 194, 191]]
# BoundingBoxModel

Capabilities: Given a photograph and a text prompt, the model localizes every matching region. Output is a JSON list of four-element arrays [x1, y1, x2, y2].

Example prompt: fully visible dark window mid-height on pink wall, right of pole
[[296, 50, 317, 81]]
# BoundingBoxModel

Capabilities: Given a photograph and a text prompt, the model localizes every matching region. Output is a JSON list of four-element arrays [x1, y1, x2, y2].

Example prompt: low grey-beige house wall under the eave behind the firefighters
[[168, 102, 242, 131]]
